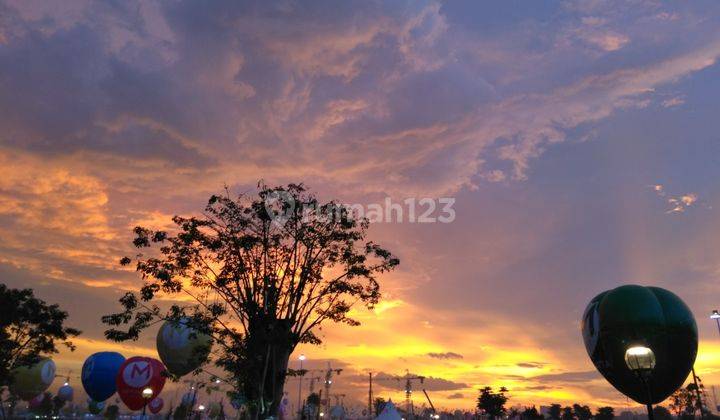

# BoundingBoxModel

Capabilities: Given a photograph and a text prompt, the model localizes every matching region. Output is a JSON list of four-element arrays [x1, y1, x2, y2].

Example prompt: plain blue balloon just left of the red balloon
[[81, 351, 125, 401]]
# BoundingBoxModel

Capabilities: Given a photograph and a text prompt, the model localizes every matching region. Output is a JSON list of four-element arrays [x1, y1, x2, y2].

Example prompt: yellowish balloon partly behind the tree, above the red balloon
[[156, 318, 212, 376]]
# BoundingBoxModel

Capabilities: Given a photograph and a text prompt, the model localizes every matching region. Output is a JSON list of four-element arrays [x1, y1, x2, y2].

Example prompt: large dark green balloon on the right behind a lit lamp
[[582, 285, 698, 404]]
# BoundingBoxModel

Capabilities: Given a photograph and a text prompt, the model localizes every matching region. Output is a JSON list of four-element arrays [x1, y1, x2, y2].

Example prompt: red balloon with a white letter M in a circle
[[116, 356, 165, 410]]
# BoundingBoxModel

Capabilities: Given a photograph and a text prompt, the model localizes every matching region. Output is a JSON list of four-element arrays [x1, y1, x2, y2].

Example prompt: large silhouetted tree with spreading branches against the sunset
[[103, 184, 399, 416]]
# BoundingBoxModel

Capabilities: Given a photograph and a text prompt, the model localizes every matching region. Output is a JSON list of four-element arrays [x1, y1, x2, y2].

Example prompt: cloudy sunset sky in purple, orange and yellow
[[0, 0, 720, 414]]
